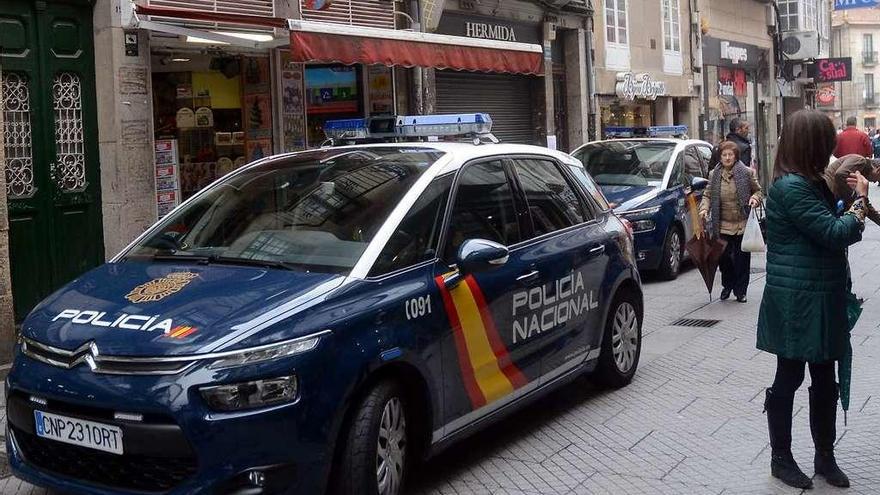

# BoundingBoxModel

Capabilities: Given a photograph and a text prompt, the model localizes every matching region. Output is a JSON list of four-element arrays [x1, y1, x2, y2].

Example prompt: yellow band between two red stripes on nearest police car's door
[[450, 283, 514, 403]]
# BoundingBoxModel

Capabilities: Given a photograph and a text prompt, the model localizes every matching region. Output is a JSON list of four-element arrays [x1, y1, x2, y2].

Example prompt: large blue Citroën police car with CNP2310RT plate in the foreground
[[6, 118, 642, 495]]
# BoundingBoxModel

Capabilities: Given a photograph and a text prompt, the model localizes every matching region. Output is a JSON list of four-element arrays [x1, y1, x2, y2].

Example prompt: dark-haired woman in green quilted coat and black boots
[[758, 110, 868, 488]]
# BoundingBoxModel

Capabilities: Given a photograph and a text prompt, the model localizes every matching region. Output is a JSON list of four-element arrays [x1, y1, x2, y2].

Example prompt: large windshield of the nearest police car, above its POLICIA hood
[[126, 147, 443, 274]]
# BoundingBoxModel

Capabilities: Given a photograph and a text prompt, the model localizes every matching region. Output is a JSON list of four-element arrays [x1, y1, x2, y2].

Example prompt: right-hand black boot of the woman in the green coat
[[810, 384, 849, 488]]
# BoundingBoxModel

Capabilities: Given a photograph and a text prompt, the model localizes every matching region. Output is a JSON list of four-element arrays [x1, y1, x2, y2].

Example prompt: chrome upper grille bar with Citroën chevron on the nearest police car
[[21, 338, 196, 375]]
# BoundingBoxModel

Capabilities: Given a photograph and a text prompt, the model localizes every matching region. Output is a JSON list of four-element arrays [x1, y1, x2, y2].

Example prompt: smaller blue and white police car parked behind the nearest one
[[572, 126, 712, 280]]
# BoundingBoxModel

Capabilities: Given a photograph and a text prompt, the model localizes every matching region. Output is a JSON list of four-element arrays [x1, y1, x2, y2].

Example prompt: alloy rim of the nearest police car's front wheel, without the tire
[[376, 397, 406, 495]]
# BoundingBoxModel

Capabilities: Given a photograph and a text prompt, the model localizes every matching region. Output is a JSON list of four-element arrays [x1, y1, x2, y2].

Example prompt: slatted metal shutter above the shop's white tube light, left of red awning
[[147, 0, 275, 34]]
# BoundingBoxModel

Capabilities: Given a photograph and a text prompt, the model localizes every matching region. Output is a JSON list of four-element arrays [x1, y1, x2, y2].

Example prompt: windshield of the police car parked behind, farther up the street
[[574, 140, 675, 187]]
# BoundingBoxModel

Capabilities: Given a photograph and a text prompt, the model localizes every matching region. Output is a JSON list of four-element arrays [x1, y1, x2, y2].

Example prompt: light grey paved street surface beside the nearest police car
[[0, 225, 880, 495]]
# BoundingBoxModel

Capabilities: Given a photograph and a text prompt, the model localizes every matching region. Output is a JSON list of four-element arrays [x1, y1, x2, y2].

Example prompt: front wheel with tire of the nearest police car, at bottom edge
[[335, 381, 412, 495]]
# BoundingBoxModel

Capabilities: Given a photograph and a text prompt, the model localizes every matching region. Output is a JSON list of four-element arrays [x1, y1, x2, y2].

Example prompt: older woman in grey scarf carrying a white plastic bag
[[700, 141, 763, 303]]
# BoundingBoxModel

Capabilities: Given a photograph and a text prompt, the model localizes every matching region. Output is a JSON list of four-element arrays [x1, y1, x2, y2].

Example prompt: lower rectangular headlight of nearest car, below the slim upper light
[[200, 375, 299, 412]]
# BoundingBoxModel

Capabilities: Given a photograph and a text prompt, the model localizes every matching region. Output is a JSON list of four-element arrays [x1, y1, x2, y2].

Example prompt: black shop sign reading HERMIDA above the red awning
[[437, 12, 543, 44]]
